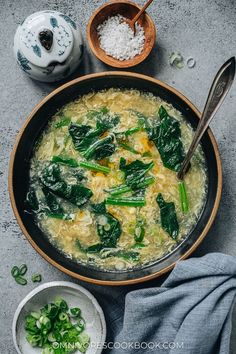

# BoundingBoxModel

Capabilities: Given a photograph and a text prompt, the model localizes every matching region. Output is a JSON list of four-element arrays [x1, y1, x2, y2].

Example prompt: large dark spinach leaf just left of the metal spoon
[[145, 106, 185, 172]]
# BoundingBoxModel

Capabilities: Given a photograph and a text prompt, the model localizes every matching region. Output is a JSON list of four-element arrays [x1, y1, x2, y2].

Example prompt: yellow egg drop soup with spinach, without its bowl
[[26, 89, 207, 270]]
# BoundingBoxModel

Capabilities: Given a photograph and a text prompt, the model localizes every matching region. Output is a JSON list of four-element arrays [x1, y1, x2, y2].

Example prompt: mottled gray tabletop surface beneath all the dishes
[[0, 0, 236, 354]]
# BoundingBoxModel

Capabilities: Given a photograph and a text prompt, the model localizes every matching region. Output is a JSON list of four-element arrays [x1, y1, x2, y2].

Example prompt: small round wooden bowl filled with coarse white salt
[[87, 1, 156, 68]]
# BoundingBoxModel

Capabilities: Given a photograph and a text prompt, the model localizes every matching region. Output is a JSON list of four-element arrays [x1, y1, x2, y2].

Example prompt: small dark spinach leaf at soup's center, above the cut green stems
[[120, 157, 154, 189]]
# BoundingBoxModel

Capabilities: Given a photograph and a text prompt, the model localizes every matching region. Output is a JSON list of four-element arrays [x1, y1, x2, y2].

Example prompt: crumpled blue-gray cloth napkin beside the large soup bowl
[[99, 253, 236, 354]]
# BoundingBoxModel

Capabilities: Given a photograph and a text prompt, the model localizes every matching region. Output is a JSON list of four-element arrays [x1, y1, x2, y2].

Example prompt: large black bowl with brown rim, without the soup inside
[[9, 72, 222, 285]]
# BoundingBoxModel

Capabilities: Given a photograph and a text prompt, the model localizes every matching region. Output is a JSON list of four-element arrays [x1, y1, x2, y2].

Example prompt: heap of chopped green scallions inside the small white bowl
[[25, 298, 90, 354]]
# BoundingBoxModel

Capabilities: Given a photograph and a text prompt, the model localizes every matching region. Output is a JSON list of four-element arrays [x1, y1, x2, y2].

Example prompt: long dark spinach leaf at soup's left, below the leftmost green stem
[[39, 163, 93, 207]]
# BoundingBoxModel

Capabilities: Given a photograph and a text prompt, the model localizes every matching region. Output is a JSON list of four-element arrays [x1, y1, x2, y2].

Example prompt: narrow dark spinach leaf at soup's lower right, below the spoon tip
[[156, 193, 179, 240]]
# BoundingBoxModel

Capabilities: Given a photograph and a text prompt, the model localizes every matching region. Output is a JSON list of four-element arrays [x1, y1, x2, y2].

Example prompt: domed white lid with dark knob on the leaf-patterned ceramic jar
[[19, 11, 74, 68]]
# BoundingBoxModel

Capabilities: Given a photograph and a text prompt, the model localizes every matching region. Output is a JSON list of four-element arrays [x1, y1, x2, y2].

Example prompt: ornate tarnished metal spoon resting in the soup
[[177, 57, 235, 180]]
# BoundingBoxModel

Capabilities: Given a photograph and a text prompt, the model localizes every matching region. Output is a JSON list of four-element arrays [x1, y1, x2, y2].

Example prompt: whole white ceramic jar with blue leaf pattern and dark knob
[[14, 11, 83, 82]]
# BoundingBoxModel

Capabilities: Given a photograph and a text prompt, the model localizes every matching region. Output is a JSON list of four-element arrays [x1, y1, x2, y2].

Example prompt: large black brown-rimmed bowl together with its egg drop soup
[[9, 72, 222, 285]]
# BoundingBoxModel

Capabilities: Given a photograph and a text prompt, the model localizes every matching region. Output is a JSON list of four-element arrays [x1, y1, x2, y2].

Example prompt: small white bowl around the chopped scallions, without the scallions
[[12, 281, 106, 354]]
